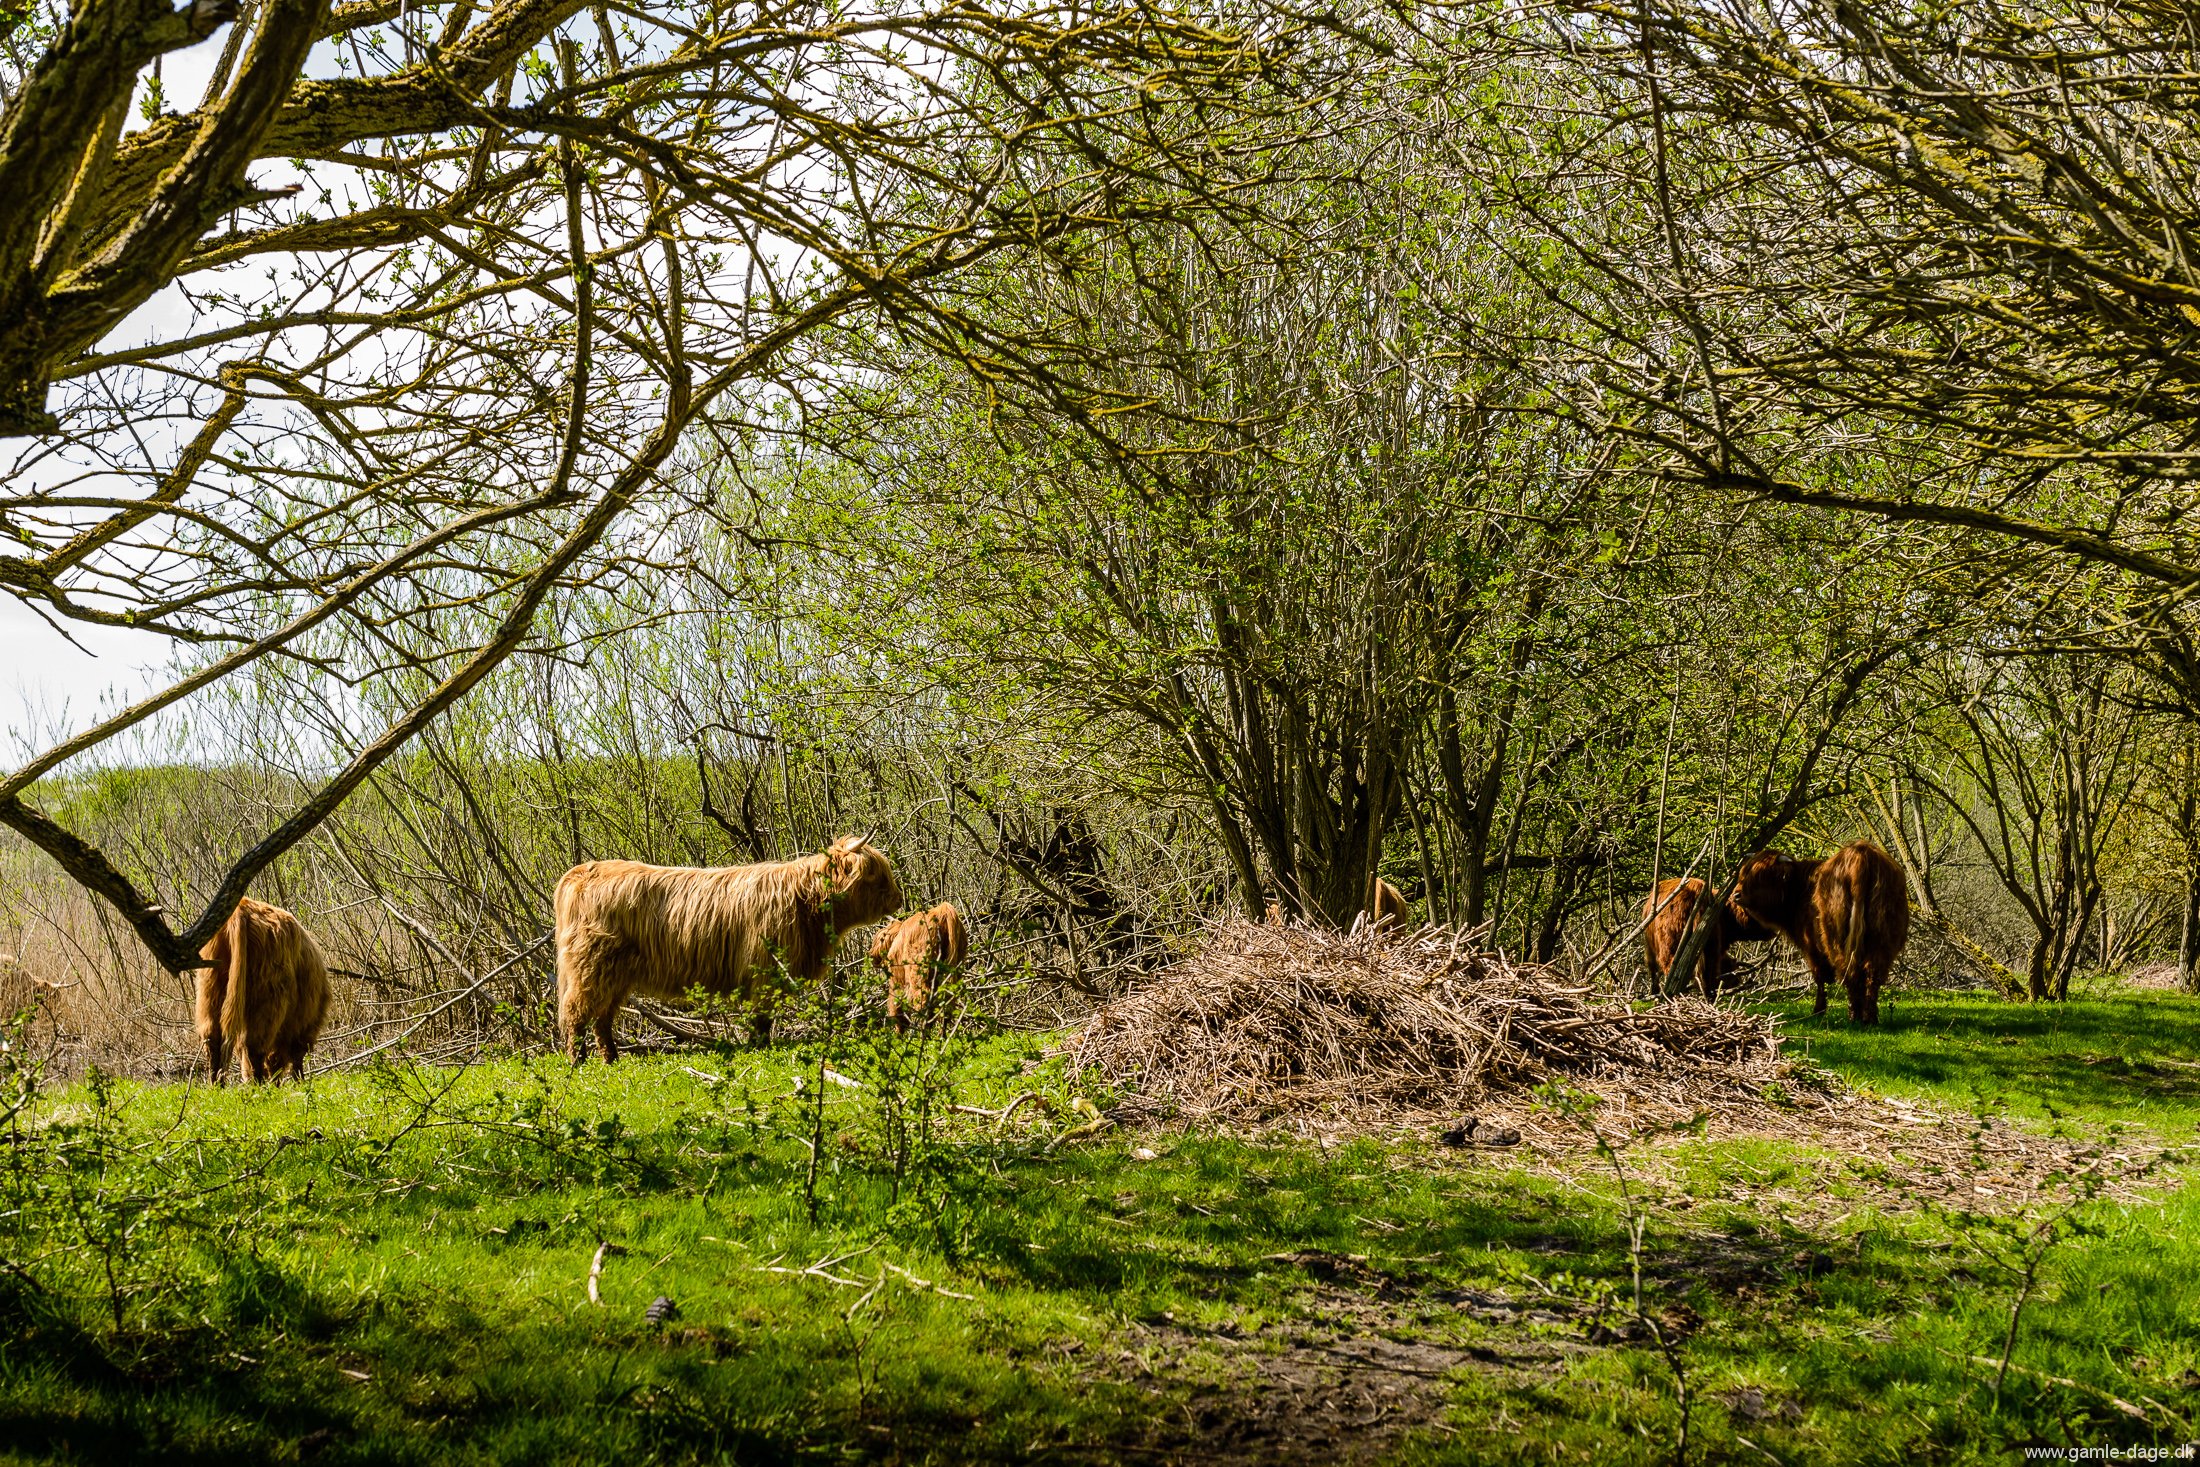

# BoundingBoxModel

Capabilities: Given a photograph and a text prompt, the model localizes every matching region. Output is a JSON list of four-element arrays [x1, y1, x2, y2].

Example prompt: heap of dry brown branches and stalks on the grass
[[1071, 922, 1789, 1130]]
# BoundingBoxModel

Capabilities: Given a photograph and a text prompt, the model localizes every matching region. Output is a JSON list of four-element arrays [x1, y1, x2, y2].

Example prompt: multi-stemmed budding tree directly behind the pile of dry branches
[[708, 91, 1938, 957]]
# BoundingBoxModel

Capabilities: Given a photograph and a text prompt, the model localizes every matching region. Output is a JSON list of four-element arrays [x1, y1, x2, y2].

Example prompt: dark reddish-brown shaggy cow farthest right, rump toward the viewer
[[1734, 840, 1910, 1025]]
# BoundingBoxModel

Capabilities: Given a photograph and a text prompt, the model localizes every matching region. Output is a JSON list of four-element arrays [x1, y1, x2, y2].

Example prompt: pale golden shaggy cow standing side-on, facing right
[[557, 836, 902, 1065]]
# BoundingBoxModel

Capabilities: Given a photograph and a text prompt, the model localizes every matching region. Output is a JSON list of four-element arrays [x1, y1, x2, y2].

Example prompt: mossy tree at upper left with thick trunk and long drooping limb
[[0, 0, 1342, 968]]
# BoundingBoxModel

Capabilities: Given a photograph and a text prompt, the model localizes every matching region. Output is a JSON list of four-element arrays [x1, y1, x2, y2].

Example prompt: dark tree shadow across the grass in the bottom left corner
[[0, 1320, 1034, 1467]]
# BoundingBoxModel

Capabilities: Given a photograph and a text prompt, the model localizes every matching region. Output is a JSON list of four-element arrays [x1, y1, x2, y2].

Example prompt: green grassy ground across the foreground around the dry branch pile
[[0, 994, 2200, 1463]]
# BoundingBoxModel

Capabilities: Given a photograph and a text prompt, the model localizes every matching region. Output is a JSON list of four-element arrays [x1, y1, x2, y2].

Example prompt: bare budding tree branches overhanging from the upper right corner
[[1467, 0, 2200, 990]]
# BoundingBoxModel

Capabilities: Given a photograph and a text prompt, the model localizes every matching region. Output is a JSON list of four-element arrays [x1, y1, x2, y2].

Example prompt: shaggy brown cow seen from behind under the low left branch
[[198, 897, 328, 1084]]
